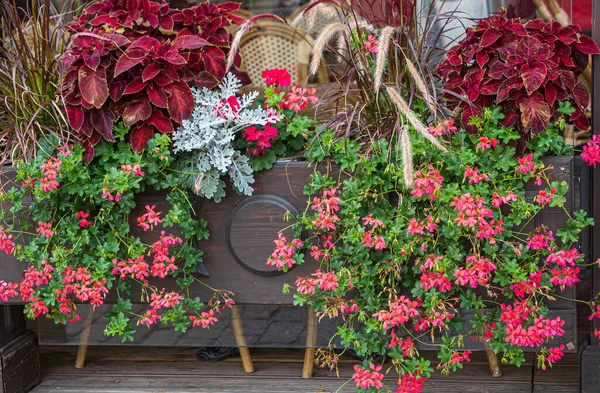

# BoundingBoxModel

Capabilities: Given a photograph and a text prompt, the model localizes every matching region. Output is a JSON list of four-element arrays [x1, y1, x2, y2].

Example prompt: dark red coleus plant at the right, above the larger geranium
[[437, 10, 600, 147]]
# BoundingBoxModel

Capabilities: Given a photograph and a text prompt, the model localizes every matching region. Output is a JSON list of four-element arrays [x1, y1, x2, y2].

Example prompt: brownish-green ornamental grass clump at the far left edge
[[0, 0, 71, 166]]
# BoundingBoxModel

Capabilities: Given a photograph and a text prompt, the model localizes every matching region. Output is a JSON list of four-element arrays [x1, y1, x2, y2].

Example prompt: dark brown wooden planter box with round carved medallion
[[0, 157, 581, 350]]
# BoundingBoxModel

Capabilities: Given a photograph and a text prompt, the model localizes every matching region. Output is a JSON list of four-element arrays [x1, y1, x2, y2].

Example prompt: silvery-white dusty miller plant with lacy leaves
[[173, 73, 282, 202]]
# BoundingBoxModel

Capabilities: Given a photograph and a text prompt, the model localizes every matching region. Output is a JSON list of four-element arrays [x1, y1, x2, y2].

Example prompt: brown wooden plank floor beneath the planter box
[[33, 346, 579, 393]]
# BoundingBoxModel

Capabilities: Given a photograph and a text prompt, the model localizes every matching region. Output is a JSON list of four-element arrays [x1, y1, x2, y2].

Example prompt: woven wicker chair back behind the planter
[[239, 21, 329, 86]]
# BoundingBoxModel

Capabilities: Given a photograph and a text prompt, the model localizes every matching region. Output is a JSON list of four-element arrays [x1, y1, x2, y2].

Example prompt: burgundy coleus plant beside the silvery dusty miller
[[59, 0, 243, 161]]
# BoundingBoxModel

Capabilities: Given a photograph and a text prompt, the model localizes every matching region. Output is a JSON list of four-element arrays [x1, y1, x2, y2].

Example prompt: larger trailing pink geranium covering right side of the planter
[[267, 104, 600, 392]]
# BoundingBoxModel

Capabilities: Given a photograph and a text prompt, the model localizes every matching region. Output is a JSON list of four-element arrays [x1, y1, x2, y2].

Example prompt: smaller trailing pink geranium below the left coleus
[[0, 130, 233, 341]]
